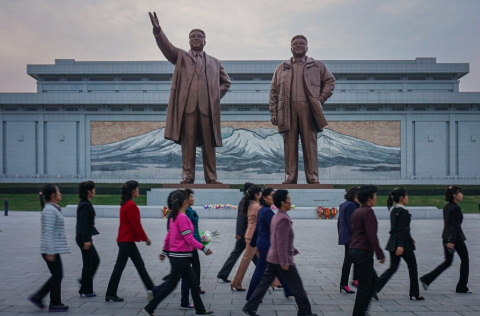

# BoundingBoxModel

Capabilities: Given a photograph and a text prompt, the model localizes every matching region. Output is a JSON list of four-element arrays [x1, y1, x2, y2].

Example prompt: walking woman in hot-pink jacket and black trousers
[[142, 191, 213, 316]]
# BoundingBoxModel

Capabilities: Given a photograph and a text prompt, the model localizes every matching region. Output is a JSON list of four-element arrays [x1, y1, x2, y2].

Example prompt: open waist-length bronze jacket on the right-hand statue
[[270, 57, 335, 133]]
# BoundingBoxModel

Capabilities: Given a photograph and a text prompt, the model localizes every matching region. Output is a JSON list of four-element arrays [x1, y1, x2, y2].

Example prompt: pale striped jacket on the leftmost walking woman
[[40, 203, 70, 255]]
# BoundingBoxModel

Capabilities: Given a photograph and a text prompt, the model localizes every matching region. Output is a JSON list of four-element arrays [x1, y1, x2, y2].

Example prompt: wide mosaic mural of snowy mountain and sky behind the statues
[[91, 121, 400, 183]]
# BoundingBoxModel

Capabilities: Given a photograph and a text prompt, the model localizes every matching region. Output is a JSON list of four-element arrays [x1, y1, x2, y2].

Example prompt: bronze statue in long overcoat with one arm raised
[[148, 12, 231, 184]]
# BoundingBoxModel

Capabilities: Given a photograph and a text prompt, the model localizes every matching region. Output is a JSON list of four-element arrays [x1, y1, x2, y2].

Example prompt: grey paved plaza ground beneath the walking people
[[0, 210, 480, 316]]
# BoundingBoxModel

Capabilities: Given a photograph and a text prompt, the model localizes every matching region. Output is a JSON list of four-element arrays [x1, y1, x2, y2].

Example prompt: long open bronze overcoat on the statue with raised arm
[[154, 30, 231, 147]]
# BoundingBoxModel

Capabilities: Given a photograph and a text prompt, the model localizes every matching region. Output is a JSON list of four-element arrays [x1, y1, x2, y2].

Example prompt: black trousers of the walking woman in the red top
[[105, 242, 153, 296]]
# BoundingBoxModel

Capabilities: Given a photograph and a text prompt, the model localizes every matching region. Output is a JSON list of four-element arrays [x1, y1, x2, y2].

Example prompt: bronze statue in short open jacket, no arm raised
[[270, 35, 335, 184]]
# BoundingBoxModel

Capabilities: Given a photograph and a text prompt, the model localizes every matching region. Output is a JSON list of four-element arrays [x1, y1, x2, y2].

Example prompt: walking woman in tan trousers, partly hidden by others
[[230, 185, 262, 292]]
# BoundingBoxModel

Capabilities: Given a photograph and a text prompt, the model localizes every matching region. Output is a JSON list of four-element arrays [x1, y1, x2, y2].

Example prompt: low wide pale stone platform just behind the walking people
[[62, 205, 443, 221]]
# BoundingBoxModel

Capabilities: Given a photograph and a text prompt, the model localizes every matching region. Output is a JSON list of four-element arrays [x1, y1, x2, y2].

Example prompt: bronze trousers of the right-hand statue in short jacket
[[283, 102, 318, 183]]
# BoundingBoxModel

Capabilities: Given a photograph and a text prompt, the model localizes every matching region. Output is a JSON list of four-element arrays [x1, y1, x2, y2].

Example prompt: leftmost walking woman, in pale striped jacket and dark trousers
[[28, 184, 70, 312]]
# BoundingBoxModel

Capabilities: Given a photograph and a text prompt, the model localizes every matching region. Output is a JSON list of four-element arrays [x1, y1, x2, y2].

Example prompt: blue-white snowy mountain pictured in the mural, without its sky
[[91, 127, 400, 176]]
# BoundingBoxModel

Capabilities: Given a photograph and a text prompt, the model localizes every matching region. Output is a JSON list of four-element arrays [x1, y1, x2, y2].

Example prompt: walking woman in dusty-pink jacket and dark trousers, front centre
[[242, 190, 316, 316]]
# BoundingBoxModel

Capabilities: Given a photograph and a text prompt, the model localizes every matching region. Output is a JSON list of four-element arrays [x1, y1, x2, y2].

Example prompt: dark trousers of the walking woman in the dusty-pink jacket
[[245, 262, 312, 316]]
